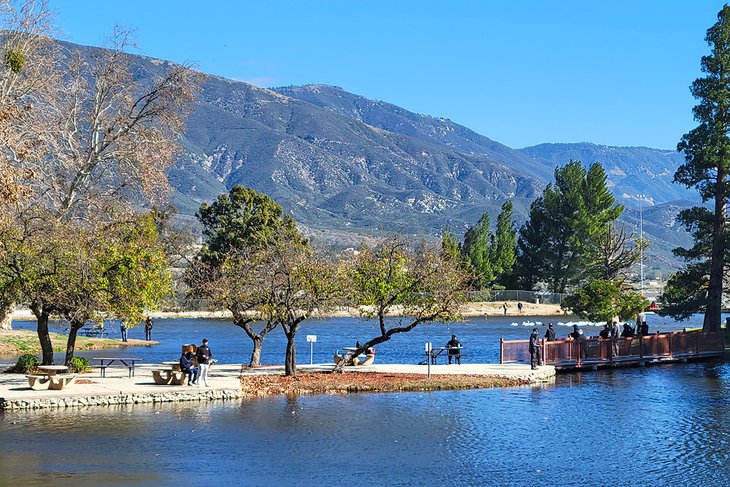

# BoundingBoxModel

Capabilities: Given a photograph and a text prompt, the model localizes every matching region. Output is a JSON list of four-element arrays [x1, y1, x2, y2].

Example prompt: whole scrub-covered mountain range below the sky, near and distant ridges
[[54, 43, 692, 270]]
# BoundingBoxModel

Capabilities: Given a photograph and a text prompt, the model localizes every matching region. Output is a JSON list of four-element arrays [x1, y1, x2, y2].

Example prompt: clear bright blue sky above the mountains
[[50, 0, 723, 149]]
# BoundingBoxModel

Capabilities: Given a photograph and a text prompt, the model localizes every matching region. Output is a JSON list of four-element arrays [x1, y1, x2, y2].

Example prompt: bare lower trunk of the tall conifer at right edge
[[702, 164, 726, 332]]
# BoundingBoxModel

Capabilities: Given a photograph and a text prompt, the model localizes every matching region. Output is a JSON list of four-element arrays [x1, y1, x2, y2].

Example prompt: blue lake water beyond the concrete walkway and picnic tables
[[0, 315, 702, 364]]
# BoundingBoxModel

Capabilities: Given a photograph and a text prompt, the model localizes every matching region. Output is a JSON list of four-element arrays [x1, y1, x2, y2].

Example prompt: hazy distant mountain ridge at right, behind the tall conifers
[[520, 142, 699, 206]]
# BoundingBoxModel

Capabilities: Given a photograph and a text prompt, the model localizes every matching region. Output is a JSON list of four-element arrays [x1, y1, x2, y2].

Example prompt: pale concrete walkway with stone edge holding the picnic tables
[[0, 364, 555, 409]]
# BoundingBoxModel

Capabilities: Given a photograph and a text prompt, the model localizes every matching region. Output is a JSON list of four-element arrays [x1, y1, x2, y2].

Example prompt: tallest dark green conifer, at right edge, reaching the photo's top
[[674, 5, 730, 331]]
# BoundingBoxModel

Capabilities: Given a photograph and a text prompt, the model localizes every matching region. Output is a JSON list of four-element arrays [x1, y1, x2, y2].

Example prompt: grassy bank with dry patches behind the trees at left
[[0, 330, 158, 356]]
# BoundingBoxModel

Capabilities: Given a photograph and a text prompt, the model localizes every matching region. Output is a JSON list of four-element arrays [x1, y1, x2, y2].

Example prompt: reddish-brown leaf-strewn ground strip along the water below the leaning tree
[[241, 372, 530, 396]]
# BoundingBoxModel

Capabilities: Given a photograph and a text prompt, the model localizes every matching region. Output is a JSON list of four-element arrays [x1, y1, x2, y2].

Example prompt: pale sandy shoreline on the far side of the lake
[[13, 301, 565, 321]]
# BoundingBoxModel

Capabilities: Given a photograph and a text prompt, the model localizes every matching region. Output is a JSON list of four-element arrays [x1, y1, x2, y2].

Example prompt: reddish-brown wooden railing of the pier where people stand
[[499, 331, 725, 367]]
